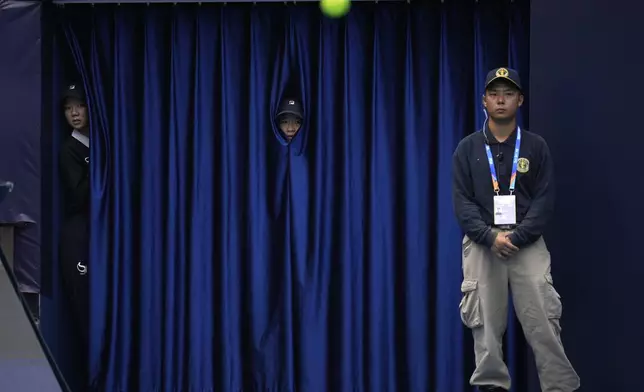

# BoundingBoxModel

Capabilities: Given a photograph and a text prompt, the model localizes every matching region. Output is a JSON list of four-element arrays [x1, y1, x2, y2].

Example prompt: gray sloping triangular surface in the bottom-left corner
[[0, 256, 62, 392]]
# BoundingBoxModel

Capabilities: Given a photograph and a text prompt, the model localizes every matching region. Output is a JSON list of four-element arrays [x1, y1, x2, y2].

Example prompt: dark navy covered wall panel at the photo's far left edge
[[0, 0, 41, 293]]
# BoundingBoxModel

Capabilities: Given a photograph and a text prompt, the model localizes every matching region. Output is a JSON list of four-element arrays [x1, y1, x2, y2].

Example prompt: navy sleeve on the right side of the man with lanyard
[[510, 139, 555, 248]]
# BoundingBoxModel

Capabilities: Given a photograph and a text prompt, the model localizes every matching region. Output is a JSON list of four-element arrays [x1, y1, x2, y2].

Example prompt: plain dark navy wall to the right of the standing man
[[530, 0, 644, 392]]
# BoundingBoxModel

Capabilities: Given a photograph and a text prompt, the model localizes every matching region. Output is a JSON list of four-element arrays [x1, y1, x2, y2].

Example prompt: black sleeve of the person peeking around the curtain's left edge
[[59, 146, 89, 212]]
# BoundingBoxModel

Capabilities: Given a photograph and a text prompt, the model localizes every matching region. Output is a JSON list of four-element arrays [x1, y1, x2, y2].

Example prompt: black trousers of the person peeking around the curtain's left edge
[[59, 216, 90, 385]]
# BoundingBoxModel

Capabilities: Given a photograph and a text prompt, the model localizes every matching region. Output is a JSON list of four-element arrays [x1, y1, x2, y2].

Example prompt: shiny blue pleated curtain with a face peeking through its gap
[[44, 1, 536, 392]]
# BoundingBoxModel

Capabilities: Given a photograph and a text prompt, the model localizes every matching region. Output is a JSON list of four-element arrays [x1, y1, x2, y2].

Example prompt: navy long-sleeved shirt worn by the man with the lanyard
[[452, 127, 555, 248]]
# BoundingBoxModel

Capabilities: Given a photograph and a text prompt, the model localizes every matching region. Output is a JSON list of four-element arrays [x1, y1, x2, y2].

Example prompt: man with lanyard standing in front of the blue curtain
[[452, 68, 580, 392]]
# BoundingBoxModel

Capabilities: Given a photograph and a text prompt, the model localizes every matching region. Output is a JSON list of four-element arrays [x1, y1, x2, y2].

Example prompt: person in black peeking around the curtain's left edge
[[59, 84, 90, 380]]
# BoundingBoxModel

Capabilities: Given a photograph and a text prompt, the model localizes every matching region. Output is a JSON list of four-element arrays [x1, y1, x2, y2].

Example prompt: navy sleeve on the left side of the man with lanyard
[[452, 143, 496, 247]]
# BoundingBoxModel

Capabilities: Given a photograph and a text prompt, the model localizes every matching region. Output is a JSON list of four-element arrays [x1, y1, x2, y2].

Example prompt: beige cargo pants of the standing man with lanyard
[[459, 236, 579, 392]]
